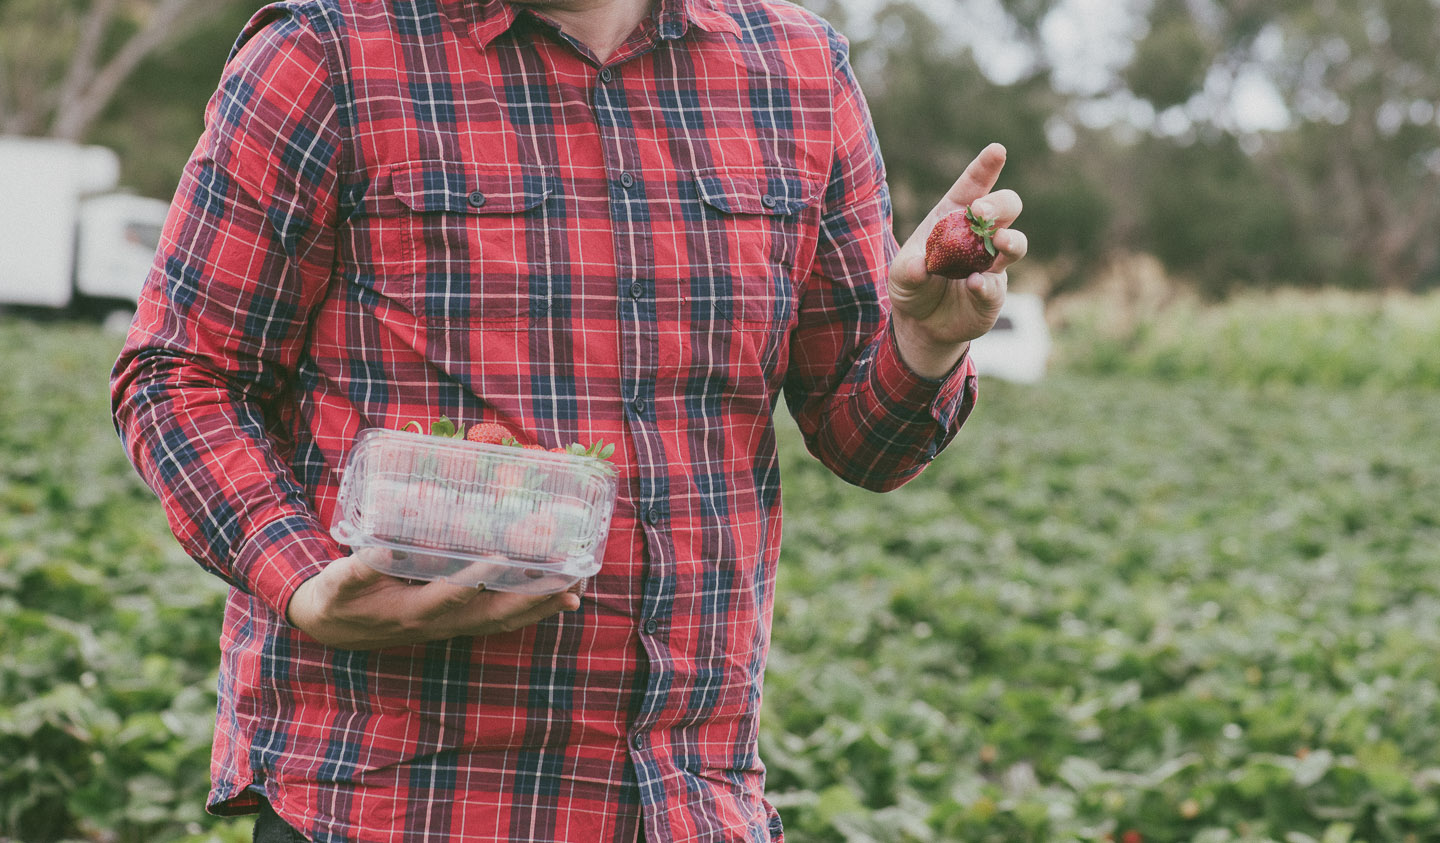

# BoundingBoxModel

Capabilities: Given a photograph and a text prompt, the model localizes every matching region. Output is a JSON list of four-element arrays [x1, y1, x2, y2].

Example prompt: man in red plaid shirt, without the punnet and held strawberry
[[112, 0, 1025, 843]]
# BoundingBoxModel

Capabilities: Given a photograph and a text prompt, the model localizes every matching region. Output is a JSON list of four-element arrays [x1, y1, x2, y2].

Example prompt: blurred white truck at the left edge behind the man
[[0, 137, 168, 322]]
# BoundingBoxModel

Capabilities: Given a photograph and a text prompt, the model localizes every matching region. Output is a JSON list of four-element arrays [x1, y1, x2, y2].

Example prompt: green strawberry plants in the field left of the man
[[0, 320, 248, 843]]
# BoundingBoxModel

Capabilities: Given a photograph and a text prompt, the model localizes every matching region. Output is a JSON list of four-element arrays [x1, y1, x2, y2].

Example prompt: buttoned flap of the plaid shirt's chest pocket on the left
[[393, 161, 550, 213]]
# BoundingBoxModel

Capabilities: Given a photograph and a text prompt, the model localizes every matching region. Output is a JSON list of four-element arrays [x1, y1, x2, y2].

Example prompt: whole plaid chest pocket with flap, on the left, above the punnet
[[377, 160, 552, 324]]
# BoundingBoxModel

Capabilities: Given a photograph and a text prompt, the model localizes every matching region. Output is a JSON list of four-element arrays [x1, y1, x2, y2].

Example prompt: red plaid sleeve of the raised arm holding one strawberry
[[785, 33, 976, 491]]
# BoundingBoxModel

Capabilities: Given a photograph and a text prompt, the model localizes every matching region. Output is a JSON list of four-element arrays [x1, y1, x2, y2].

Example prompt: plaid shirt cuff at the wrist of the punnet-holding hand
[[233, 514, 341, 618]]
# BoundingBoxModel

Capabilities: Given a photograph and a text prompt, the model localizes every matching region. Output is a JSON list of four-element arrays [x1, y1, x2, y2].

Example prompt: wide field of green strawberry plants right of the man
[[762, 324, 1440, 843]]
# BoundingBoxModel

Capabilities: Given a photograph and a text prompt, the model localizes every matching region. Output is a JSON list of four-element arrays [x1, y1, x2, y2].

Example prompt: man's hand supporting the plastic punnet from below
[[285, 548, 580, 650]]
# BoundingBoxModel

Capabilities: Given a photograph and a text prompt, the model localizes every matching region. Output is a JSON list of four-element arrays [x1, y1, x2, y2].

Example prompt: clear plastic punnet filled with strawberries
[[330, 428, 615, 594]]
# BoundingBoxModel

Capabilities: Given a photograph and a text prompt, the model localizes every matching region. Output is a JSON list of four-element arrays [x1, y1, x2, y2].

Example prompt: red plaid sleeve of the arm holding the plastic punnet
[[111, 12, 341, 614]]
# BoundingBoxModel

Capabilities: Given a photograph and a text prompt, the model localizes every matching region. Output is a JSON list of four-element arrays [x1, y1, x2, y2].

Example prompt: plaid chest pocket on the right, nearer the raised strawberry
[[681, 169, 821, 330]]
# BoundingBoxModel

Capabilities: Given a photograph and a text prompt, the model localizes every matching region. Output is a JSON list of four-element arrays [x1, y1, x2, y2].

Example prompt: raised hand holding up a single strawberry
[[890, 144, 1028, 378]]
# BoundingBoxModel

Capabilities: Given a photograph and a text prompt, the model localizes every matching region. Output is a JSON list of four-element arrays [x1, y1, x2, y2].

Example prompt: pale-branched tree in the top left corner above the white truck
[[0, 0, 249, 140]]
